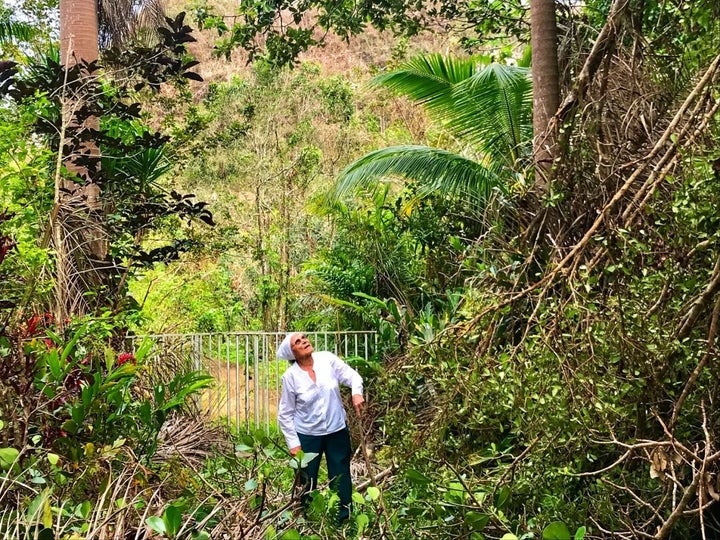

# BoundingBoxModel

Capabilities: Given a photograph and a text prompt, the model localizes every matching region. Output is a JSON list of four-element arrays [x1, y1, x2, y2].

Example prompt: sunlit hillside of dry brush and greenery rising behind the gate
[[131, 2, 446, 332]]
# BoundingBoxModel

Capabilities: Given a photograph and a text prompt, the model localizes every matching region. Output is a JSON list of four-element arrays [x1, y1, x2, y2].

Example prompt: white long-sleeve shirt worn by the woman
[[278, 351, 363, 448]]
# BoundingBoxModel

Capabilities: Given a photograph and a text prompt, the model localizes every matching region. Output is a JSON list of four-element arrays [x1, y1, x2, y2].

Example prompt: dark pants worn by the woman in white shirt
[[298, 427, 352, 523]]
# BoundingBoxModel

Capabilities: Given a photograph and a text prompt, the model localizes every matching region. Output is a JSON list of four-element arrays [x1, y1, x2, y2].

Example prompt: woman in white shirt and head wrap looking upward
[[277, 332, 365, 523]]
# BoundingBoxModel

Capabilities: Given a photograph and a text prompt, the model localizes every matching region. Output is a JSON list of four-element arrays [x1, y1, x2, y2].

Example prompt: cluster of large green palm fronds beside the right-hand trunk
[[333, 54, 532, 204]]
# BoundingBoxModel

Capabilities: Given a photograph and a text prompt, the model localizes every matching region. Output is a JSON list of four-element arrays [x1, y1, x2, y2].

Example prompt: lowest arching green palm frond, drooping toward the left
[[331, 146, 505, 204]]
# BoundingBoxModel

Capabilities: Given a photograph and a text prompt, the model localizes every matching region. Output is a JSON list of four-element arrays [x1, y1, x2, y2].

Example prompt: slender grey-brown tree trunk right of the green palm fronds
[[530, 0, 560, 191]]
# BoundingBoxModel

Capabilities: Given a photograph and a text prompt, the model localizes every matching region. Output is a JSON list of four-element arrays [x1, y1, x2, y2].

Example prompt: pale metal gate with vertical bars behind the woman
[[130, 332, 377, 432]]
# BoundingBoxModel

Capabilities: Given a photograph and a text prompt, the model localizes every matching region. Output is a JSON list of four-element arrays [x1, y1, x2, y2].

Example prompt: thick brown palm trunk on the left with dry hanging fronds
[[53, 0, 164, 321]]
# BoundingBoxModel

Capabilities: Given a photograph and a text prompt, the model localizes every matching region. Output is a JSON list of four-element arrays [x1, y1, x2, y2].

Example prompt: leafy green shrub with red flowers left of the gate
[[2, 320, 212, 463]]
